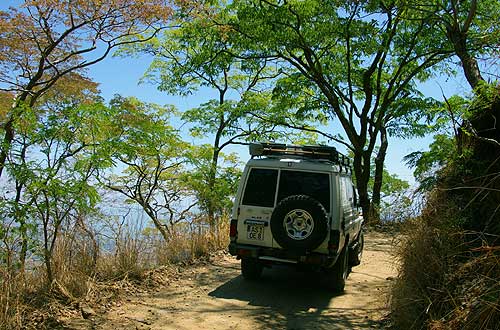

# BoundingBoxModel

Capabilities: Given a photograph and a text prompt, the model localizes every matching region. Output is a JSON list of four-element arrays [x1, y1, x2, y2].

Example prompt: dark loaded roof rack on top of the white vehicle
[[249, 142, 351, 168]]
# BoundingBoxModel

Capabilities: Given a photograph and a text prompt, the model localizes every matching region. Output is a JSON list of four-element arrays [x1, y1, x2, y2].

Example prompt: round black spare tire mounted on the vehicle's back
[[271, 195, 328, 254]]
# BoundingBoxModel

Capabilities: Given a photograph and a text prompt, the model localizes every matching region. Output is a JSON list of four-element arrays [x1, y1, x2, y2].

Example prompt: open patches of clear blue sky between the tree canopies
[[0, 0, 476, 184]]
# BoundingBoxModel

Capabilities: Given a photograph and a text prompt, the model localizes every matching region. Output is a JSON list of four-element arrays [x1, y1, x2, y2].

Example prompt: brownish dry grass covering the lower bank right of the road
[[391, 194, 500, 330]]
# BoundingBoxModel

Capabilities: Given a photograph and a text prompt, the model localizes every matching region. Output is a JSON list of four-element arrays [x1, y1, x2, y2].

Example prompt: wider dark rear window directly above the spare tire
[[278, 170, 330, 211]]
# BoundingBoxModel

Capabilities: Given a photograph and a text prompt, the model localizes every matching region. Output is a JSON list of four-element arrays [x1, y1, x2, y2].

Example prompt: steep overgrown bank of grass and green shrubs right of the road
[[391, 86, 500, 329]]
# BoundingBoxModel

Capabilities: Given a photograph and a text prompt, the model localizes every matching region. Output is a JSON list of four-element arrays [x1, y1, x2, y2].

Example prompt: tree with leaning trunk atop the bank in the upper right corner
[[406, 0, 500, 189]]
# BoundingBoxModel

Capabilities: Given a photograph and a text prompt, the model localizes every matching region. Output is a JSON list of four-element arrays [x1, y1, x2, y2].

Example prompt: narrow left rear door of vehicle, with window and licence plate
[[238, 168, 278, 247]]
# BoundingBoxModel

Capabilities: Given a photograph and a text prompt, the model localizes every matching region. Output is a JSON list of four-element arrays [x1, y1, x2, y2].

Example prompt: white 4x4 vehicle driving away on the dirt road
[[229, 143, 363, 292]]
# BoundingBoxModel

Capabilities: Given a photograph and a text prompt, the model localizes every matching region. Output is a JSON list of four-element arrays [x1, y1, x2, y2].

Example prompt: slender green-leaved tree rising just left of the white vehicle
[[126, 6, 286, 227]]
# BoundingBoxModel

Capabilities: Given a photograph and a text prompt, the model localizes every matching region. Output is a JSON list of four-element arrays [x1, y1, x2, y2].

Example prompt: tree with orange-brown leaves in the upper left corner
[[0, 0, 171, 177]]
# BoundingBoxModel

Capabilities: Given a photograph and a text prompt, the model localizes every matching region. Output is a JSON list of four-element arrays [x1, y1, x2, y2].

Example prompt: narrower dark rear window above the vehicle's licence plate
[[243, 168, 278, 207]]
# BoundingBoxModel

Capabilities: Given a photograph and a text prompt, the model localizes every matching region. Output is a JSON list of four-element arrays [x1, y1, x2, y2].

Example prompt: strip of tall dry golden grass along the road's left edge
[[0, 215, 229, 330]]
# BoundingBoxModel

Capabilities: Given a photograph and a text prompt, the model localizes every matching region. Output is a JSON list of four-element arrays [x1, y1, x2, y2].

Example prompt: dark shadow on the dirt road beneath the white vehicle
[[209, 267, 377, 329]]
